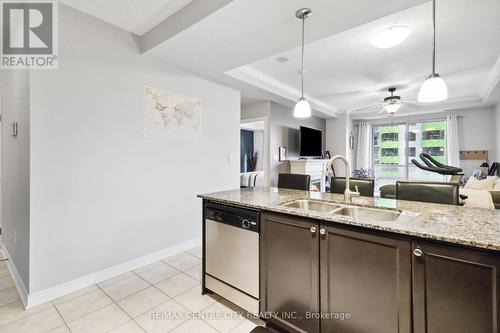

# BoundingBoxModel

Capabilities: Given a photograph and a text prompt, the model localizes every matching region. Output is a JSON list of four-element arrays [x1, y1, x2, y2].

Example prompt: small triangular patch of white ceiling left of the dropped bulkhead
[[60, 0, 192, 36]]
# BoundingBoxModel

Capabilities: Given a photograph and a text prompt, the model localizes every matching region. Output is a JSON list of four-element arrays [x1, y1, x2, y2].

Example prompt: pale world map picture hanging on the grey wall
[[144, 86, 201, 140]]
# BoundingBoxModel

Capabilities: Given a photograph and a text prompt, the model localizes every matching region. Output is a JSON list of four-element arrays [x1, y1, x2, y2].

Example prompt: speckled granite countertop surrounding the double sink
[[198, 187, 500, 251]]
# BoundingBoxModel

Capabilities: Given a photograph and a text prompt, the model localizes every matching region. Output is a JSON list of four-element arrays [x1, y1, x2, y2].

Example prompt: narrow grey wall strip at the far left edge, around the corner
[[0, 69, 30, 291]]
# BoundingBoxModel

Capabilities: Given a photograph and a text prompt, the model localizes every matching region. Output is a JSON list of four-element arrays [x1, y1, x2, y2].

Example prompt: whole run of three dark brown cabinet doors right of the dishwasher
[[260, 213, 500, 333]]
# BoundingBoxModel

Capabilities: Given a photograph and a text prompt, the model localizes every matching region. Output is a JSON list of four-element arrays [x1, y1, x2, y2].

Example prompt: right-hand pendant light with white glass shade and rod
[[418, 0, 448, 103]]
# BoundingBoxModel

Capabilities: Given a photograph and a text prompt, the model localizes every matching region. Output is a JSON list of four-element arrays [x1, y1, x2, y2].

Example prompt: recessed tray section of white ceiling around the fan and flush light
[[230, 0, 500, 118]]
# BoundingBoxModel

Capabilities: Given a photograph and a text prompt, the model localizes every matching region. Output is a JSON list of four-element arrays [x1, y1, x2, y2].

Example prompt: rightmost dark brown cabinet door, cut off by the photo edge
[[413, 243, 500, 333]]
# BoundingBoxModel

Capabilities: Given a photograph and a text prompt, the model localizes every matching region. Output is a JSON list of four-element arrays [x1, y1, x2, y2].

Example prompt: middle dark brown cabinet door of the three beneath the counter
[[320, 226, 411, 333]]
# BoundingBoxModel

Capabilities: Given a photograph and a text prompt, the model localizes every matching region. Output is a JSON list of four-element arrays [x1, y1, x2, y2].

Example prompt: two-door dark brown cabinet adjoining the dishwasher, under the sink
[[261, 214, 411, 333]]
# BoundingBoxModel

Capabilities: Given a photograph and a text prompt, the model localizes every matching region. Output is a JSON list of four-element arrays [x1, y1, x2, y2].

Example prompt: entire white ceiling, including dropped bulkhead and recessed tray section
[[61, 0, 500, 118]]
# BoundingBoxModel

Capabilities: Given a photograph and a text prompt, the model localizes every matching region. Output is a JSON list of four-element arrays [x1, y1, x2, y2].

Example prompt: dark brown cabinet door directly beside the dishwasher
[[261, 213, 319, 333]]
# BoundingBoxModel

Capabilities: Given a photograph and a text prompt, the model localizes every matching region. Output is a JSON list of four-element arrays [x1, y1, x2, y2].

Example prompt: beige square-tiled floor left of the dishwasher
[[0, 247, 263, 333]]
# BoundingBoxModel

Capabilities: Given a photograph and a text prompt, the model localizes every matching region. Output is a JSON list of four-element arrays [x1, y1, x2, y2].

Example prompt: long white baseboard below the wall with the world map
[[25, 238, 201, 309]]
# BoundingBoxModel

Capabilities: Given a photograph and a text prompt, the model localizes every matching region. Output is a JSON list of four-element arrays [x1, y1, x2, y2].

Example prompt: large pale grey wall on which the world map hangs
[[30, 5, 240, 292]]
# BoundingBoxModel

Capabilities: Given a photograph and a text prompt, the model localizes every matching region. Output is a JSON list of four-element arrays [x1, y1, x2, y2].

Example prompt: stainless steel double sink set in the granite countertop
[[282, 199, 401, 221]]
